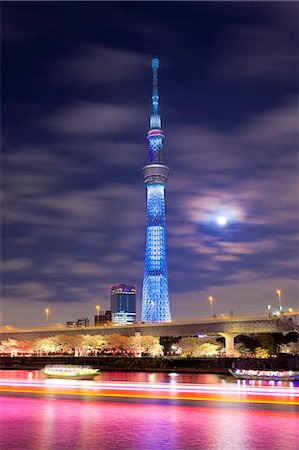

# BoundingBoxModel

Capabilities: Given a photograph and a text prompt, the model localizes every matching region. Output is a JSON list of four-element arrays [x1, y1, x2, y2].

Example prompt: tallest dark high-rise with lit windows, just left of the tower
[[111, 284, 136, 325]]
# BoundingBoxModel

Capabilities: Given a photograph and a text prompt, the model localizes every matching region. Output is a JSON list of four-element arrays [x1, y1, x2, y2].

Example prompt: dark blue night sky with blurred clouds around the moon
[[1, 2, 299, 326]]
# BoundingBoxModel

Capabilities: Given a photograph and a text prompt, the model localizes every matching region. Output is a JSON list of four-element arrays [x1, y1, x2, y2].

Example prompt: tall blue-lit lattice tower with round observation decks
[[141, 58, 171, 322]]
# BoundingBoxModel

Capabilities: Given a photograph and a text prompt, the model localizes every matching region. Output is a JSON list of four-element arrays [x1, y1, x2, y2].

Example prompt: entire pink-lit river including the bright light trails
[[0, 370, 299, 450]]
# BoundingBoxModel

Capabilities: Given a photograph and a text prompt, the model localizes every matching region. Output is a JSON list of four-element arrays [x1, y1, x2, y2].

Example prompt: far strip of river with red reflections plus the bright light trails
[[0, 370, 299, 408]]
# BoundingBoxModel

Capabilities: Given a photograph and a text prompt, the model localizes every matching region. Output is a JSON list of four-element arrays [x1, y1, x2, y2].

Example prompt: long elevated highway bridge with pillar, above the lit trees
[[0, 311, 299, 355]]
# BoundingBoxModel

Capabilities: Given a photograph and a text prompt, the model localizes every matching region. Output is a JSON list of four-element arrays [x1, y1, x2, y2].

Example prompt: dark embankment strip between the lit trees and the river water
[[0, 356, 299, 374]]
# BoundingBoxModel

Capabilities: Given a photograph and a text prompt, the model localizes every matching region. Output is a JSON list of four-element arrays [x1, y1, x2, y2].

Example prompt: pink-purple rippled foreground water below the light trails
[[0, 397, 299, 450]]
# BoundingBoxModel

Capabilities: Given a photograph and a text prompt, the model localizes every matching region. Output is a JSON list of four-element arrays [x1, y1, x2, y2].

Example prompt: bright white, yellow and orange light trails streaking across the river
[[0, 379, 299, 407]]
